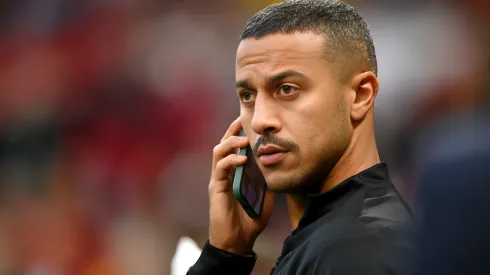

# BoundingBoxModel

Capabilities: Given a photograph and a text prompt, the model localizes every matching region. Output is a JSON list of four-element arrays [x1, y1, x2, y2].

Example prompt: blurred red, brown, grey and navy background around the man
[[0, 0, 490, 275]]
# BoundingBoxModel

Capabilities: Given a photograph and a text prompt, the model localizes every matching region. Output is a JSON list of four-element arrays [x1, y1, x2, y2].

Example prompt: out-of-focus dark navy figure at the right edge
[[414, 112, 490, 275]]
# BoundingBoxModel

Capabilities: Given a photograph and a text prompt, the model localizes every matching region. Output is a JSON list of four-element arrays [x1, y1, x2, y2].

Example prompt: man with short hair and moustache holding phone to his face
[[188, 0, 412, 275]]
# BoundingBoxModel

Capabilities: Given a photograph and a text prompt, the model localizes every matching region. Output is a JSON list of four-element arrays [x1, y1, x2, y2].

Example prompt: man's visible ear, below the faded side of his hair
[[350, 72, 379, 121]]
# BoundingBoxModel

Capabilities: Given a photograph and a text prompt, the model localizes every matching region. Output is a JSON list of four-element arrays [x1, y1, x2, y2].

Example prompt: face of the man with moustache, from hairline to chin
[[236, 33, 352, 192]]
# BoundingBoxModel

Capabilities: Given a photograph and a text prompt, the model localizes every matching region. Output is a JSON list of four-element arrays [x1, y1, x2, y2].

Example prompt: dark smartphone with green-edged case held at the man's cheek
[[233, 130, 267, 219]]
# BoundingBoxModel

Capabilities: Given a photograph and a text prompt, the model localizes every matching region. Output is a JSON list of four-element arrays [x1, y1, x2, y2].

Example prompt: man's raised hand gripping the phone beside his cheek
[[209, 119, 274, 255]]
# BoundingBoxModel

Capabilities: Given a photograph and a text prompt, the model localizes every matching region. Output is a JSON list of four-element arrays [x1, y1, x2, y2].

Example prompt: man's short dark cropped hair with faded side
[[240, 0, 378, 78]]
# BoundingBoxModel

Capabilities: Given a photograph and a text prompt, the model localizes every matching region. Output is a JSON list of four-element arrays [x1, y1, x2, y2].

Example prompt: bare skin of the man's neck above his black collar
[[286, 116, 380, 230]]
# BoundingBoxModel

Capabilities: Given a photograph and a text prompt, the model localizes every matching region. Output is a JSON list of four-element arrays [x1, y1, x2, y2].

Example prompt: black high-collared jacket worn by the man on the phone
[[187, 163, 414, 275]]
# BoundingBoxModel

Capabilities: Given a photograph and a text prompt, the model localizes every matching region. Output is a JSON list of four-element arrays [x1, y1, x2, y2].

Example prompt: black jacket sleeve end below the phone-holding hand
[[187, 242, 257, 275]]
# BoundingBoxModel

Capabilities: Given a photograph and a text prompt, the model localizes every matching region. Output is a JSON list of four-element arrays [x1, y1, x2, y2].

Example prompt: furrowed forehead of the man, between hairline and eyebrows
[[236, 32, 326, 80]]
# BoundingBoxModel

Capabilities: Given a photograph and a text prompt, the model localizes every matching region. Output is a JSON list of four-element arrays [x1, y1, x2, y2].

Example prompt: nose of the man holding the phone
[[251, 93, 281, 136]]
